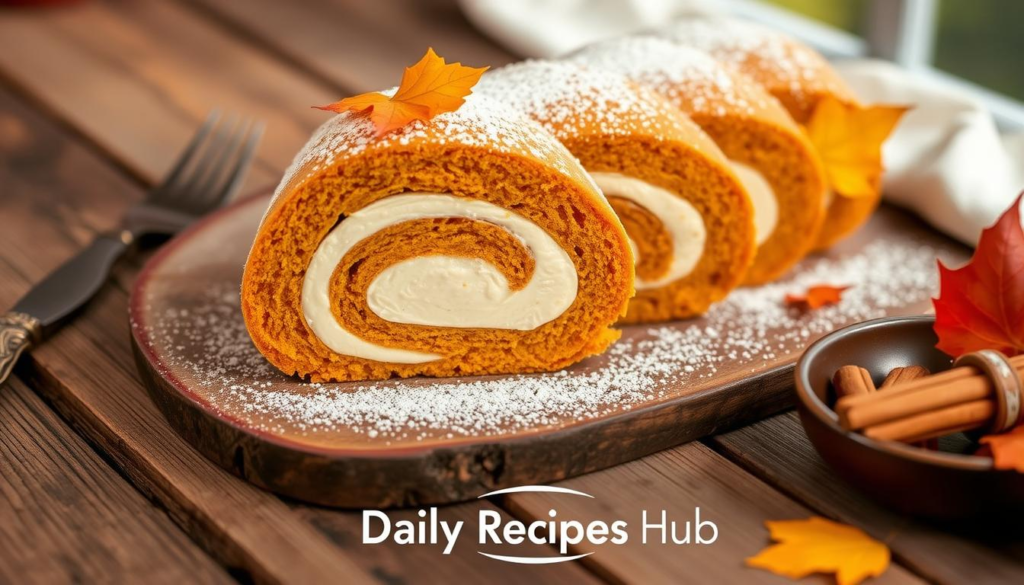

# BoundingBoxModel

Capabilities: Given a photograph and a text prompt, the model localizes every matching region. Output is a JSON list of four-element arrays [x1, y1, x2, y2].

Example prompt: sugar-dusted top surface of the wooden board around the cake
[[140, 239, 937, 445]]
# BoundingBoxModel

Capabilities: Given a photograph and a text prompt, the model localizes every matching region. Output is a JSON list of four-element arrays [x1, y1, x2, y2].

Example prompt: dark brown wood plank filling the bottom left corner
[[0, 378, 233, 583]]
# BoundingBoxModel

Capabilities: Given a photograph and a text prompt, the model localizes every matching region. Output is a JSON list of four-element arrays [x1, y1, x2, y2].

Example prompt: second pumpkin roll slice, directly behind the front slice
[[476, 60, 755, 323]]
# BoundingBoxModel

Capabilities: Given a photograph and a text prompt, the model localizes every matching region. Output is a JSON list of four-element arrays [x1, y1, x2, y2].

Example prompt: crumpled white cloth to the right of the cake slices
[[837, 60, 1024, 246]]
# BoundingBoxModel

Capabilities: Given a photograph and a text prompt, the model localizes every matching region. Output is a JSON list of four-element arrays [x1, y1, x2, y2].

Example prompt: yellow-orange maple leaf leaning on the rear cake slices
[[807, 96, 909, 198]]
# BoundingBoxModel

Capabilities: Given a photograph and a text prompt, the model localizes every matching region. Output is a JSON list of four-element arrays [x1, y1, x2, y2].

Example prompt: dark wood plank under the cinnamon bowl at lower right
[[708, 413, 1024, 584]]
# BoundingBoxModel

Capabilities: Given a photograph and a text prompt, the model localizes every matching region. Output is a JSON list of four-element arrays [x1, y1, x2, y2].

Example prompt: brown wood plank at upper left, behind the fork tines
[[0, 1, 337, 186]]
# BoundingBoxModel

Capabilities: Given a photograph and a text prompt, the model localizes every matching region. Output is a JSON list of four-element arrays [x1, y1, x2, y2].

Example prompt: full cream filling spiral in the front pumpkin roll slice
[[302, 193, 579, 364]]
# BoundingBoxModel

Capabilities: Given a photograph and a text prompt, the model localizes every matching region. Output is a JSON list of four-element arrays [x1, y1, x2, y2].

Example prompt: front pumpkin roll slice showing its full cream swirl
[[242, 95, 634, 381]]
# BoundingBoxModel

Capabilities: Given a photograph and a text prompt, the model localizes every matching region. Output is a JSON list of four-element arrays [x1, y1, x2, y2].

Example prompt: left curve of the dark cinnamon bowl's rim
[[795, 315, 994, 471]]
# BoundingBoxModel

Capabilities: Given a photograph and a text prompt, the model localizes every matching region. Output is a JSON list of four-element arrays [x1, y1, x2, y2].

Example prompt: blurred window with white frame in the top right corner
[[732, 0, 1024, 129]]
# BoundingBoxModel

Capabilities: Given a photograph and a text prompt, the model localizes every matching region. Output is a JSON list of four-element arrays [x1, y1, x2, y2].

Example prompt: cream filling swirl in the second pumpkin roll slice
[[590, 172, 708, 290]]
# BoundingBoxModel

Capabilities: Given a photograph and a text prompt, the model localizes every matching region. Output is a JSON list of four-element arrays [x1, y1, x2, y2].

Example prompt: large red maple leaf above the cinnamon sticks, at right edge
[[932, 193, 1024, 358]]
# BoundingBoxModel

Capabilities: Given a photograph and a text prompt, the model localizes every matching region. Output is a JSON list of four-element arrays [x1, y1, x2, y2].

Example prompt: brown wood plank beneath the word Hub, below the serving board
[[502, 443, 921, 584]]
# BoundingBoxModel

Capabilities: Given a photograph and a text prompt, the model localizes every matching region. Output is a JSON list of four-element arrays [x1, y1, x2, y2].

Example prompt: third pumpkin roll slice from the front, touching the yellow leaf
[[568, 36, 825, 284]]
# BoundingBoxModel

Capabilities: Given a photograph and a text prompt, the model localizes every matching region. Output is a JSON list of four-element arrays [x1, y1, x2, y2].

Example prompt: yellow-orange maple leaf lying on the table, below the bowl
[[746, 516, 889, 585]]
